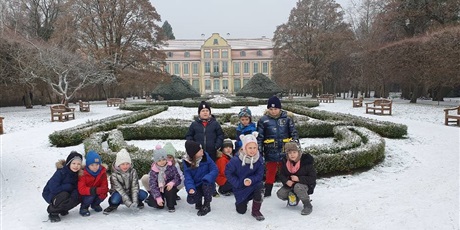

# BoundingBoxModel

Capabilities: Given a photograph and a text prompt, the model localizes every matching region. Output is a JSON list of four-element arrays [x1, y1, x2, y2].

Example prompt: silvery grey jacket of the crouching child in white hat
[[109, 164, 139, 207]]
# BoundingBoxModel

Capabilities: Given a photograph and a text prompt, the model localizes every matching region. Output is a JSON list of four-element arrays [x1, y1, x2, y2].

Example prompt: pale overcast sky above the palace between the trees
[[150, 0, 350, 39]]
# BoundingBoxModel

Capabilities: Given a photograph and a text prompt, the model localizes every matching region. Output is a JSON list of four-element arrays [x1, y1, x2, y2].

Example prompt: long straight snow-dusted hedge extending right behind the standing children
[[284, 104, 407, 138]]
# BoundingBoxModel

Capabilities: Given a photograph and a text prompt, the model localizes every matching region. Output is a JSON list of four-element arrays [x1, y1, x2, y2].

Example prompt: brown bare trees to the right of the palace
[[273, 0, 460, 103]]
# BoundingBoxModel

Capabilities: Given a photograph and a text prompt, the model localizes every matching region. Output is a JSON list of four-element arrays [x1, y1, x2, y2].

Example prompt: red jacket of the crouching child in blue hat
[[78, 165, 109, 200]]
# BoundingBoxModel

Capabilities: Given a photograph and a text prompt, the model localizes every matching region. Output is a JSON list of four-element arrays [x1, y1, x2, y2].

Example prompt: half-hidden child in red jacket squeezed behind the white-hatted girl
[[216, 139, 233, 196]]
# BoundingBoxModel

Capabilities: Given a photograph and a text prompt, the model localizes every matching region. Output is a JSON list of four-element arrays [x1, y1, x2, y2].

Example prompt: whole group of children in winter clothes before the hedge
[[43, 96, 316, 222]]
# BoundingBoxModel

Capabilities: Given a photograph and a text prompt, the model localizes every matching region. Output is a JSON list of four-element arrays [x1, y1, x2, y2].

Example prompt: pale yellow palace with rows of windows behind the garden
[[162, 33, 273, 94]]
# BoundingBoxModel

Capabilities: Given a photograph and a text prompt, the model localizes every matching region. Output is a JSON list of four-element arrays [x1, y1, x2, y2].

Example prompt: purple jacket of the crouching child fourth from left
[[149, 161, 181, 199]]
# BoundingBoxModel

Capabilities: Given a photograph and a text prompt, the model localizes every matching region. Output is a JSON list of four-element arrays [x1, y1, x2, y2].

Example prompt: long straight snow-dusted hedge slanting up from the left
[[48, 106, 168, 147]]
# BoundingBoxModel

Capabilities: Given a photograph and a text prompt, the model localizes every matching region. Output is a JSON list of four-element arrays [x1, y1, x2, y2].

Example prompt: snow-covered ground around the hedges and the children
[[0, 98, 460, 230]]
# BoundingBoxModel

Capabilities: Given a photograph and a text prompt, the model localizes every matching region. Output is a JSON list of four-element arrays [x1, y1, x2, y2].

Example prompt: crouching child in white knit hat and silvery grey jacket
[[104, 149, 148, 214]]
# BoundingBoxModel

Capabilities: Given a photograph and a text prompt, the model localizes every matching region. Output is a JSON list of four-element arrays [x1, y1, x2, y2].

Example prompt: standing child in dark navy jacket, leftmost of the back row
[[185, 101, 224, 162]]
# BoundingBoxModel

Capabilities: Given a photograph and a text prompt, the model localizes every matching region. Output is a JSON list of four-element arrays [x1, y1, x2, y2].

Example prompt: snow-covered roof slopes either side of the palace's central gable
[[161, 37, 273, 50]]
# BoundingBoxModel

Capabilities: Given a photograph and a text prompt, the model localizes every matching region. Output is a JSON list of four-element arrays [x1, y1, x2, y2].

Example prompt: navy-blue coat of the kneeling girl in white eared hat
[[225, 153, 265, 204]]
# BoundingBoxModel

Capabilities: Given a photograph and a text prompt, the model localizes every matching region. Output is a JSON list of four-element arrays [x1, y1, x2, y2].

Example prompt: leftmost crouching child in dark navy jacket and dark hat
[[42, 151, 83, 222]]
